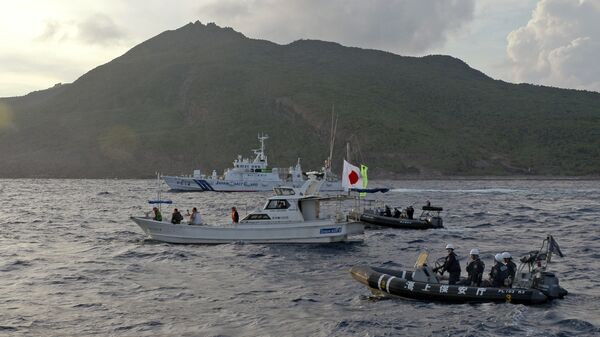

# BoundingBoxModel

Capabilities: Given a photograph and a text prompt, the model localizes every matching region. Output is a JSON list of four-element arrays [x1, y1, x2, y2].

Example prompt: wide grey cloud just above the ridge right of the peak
[[199, 0, 475, 54]]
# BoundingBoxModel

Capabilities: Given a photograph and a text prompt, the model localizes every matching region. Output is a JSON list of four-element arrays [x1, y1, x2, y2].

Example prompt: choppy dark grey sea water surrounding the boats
[[0, 180, 600, 336]]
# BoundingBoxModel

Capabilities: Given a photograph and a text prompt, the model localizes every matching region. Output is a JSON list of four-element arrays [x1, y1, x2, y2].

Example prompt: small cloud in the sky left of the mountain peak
[[36, 13, 127, 45]]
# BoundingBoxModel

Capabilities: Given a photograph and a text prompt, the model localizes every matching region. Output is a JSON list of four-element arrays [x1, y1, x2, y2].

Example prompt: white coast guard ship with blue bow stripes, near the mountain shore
[[162, 135, 305, 192]]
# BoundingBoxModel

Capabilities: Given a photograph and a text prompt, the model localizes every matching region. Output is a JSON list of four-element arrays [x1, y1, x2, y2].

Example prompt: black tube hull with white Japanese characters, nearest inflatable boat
[[350, 266, 550, 304]]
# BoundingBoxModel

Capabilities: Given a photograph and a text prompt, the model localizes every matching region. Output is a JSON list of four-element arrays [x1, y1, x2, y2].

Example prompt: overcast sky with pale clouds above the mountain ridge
[[0, 0, 600, 97]]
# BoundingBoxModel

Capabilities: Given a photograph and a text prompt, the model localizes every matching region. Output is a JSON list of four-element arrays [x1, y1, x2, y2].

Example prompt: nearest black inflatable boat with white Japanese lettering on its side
[[350, 236, 567, 304]]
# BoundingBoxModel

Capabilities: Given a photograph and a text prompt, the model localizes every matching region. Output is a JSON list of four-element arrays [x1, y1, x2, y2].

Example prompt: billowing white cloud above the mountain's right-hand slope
[[506, 0, 600, 91]]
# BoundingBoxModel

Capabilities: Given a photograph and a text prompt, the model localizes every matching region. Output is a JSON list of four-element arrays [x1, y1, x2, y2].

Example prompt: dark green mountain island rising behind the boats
[[0, 22, 600, 178]]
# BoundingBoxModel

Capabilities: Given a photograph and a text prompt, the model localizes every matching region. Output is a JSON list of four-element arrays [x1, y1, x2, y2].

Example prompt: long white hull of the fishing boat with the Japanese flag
[[131, 217, 363, 244]]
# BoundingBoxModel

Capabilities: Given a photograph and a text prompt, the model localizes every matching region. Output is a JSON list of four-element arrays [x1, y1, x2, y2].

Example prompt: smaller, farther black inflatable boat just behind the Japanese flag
[[360, 206, 444, 229]]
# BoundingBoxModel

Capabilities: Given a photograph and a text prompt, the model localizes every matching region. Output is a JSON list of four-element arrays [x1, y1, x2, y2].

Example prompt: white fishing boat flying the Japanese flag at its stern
[[131, 179, 364, 244]]
